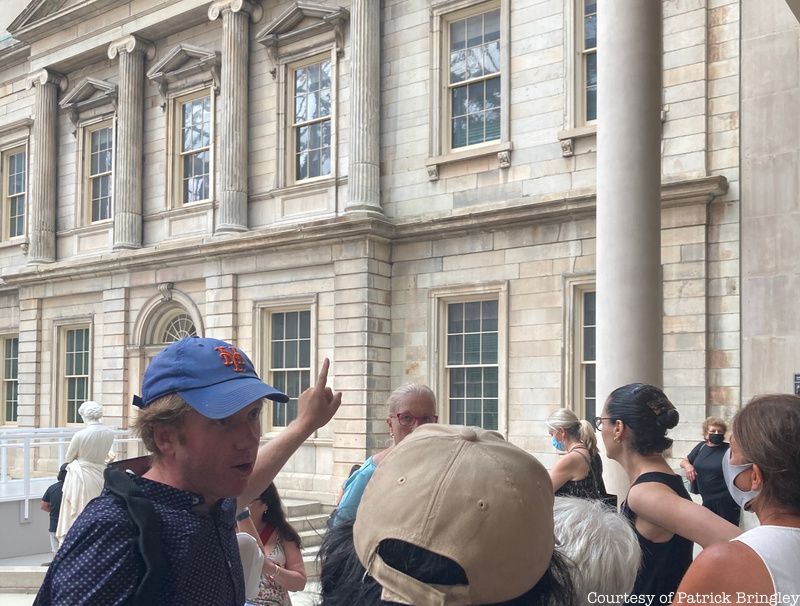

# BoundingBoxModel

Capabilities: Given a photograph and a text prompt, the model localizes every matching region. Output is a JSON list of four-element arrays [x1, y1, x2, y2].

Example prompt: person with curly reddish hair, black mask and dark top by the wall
[[680, 417, 741, 526]]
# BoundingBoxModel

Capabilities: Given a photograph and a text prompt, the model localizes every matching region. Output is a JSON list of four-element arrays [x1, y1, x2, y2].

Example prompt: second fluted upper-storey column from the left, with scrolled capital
[[108, 36, 155, 249]]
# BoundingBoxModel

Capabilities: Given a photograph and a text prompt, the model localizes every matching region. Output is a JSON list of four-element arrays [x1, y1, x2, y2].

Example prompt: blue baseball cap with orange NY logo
[[133, 337, 289, 419]]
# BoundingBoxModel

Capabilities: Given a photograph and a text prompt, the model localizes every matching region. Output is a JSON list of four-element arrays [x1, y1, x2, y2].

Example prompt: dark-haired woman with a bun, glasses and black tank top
[[595, 383, 740, 604]]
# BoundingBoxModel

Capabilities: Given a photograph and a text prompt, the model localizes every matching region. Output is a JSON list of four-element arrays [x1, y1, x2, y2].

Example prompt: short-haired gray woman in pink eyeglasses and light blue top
[[332, 383, 439, 526]]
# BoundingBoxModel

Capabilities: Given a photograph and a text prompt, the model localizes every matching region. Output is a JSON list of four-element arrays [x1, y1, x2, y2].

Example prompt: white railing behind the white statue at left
[[0, 427, 143, 520]]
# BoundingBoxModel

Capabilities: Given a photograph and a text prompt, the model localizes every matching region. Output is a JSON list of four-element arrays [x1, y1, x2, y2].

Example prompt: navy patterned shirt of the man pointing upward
[[35, 475, 245, 606]]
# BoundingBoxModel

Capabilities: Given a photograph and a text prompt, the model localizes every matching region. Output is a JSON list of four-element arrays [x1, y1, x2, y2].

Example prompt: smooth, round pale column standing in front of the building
[[597, 0, 663, 495]]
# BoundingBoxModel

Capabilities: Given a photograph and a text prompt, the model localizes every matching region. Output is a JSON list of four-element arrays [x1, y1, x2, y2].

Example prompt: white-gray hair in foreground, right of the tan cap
[[553, 497, 642, 606]]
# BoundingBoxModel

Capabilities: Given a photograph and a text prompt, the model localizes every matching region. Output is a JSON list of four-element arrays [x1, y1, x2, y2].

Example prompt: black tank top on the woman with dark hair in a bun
[[622, 471, 694, 604]]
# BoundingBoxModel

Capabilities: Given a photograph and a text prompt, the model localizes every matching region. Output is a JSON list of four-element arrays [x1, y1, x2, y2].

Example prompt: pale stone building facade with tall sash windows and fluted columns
[[0, 0, 744, 502]]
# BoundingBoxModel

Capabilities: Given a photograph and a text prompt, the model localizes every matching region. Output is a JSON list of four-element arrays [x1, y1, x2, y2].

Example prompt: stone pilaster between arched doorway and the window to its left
[[102, 288, 130, 427]]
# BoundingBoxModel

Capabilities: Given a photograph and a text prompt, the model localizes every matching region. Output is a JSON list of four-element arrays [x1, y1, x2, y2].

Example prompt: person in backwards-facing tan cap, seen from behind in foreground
[[321, 424, 577, 606]]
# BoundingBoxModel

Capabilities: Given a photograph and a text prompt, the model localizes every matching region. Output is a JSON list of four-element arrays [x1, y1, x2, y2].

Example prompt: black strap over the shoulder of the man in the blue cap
[[104, 467, 167, 606]]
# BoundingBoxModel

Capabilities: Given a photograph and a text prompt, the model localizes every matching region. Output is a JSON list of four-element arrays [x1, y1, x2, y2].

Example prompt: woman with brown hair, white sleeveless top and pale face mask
[[674, 394, 800, 604]]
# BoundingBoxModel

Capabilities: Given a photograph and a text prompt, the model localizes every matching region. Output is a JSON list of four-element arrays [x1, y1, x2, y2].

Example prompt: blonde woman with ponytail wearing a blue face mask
[[545, 408, 606, 500]]
